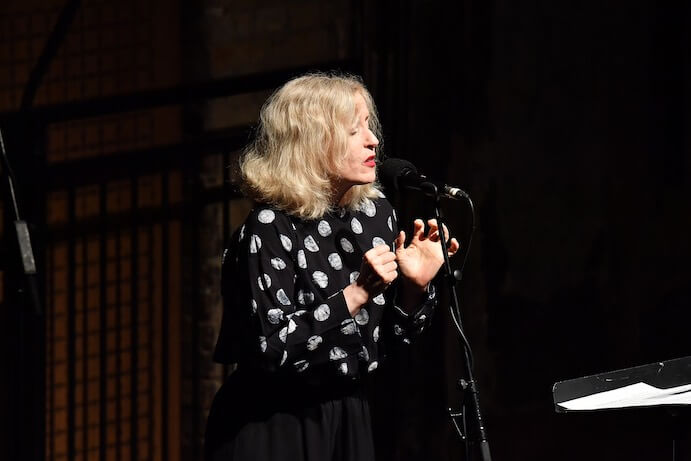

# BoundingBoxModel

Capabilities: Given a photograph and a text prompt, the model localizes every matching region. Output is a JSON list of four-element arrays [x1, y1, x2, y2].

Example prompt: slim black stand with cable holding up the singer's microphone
[[419, 182, 492, 461]]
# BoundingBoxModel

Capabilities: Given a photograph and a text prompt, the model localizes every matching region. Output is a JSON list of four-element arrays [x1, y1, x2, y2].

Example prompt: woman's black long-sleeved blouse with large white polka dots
[[214, 197, 436, 377]]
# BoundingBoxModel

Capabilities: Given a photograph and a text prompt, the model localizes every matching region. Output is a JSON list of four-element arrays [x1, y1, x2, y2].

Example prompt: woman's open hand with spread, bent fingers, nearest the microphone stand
[[395, 219, 460, 290]]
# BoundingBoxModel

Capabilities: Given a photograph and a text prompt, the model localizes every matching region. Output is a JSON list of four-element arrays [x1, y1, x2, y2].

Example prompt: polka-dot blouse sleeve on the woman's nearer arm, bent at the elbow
[[238, 209, 362, 372]]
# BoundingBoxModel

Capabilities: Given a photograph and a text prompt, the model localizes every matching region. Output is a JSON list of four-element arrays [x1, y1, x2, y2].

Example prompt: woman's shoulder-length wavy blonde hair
[[240, 73, 382, 219]]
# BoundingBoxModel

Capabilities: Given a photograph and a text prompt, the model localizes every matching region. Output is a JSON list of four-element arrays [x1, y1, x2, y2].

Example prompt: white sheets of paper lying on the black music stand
[[558, 383, 691, 411]]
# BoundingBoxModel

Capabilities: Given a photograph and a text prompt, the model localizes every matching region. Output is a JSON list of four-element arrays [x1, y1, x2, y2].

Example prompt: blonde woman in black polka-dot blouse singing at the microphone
[[205, 74, 458, 461]]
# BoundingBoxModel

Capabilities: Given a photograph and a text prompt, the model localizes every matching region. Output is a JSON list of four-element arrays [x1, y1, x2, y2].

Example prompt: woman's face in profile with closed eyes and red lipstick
[[336, 92, 379, 194]]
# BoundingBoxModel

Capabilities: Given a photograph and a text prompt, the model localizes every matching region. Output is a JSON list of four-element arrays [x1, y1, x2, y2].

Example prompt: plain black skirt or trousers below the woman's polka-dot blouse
[[204, 370, 374, 461]]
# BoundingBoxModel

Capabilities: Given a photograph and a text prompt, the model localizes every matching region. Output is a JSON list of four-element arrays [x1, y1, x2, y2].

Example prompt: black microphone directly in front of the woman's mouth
[[379, 158, 469, 200]]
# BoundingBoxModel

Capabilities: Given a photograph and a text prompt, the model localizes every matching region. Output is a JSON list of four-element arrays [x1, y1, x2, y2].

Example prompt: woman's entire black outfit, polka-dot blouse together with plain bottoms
[[207, 197, 436, 461]]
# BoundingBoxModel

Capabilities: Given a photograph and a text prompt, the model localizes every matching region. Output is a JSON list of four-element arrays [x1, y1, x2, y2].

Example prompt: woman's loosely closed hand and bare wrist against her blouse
[[343, 245, 398, 315]]
